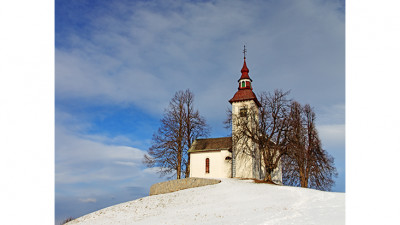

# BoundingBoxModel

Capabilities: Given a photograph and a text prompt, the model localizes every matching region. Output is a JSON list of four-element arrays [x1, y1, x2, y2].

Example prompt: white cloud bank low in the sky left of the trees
[[55, 124, 164, 193]]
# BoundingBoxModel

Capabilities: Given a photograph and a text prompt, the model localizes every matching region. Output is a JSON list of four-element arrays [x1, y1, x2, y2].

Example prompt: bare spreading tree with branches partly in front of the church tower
[[231, 90, 290, 182]]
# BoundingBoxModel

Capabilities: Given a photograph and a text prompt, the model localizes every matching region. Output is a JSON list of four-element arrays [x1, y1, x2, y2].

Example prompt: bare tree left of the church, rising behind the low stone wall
[[143, 89, 209, 179]]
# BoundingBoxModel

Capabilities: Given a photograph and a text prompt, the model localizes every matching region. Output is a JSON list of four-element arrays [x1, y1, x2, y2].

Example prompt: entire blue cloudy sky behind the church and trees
[[55, 0, 345, 221]]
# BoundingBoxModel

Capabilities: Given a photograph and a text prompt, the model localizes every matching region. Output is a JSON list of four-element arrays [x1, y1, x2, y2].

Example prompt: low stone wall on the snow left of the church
[[150, 177, 221, 195]]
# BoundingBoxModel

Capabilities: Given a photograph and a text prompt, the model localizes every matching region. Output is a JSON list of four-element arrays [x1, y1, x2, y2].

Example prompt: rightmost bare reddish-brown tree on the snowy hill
[[283, 102, 337, 190]]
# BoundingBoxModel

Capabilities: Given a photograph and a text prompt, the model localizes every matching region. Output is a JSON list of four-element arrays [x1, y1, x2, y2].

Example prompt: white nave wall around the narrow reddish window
[[190, 150, 232, 178]]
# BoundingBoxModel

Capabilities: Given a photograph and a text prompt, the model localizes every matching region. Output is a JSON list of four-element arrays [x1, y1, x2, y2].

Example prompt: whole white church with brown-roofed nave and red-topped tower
[[188, 49, 282, 184]]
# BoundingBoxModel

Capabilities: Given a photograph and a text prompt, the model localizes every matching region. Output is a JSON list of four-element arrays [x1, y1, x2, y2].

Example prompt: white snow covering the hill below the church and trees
[[68, 179, 345, 225]]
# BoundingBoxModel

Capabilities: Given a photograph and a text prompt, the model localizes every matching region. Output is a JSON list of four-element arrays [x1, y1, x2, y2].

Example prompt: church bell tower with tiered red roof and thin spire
[[229, 46, 261, 179]]
